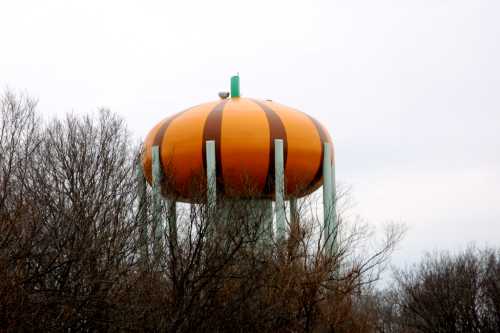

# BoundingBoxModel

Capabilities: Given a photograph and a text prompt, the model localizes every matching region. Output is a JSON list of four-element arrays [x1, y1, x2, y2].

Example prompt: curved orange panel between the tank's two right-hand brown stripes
[[265, 102, 321, 194]]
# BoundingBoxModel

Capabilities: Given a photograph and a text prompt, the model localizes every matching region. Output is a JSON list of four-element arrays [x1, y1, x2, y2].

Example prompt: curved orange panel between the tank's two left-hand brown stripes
[[161, 102, 218, 196]]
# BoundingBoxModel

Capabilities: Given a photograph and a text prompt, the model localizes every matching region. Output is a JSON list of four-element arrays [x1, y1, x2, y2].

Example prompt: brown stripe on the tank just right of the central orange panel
[[252, 99, 288, 195]]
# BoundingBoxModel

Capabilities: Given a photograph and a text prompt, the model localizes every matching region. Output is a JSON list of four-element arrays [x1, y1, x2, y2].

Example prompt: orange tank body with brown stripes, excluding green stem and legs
[[142, 97, 333, 202]]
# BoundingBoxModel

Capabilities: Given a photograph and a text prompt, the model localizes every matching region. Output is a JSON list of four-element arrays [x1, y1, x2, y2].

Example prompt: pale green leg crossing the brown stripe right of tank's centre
[[274, 139, 286, 240]]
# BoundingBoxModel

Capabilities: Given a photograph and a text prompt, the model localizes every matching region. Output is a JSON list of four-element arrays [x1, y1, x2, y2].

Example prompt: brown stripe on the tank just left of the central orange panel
[[202, 99, 228, 194]]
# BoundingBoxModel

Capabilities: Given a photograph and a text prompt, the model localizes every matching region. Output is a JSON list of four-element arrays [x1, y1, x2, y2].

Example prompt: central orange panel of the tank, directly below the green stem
[[221, 98, 270, 195]]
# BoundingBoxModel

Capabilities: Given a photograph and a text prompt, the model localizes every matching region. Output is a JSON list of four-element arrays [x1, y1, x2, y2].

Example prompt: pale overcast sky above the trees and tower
[[0, 0, 500, 265]]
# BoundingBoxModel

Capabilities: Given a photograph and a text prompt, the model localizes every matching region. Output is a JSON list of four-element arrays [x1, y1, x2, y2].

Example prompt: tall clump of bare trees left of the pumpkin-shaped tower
[[0, 93, 141, 330]]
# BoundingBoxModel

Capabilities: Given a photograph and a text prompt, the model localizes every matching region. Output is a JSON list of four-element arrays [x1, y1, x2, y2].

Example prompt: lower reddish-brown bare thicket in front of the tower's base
[[124, 175, 404, 332]]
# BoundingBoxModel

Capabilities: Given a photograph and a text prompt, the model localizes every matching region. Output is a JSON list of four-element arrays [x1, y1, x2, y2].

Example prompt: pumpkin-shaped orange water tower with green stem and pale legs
[[142, 76, 335, 250]]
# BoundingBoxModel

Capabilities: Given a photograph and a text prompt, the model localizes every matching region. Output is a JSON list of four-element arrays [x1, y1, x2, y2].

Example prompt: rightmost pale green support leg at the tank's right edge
[[323, 142, 336, 255]]
